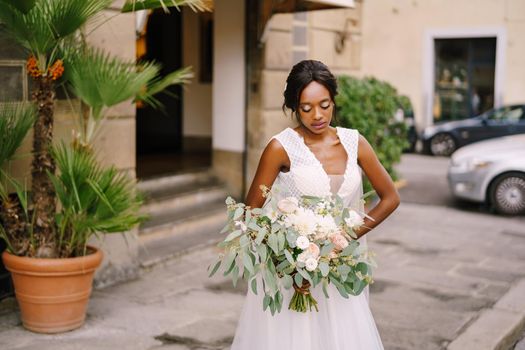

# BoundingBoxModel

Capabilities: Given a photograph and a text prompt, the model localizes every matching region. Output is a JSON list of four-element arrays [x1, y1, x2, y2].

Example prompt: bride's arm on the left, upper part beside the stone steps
[[245, 139, 290, 208]]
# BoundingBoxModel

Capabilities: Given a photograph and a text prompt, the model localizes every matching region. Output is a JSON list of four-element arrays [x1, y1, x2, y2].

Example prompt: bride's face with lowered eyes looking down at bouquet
[[298, 81, 334, 134]]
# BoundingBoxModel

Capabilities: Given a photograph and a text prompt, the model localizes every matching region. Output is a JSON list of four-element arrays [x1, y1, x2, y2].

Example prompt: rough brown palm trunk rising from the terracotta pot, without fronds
[[31, 76, 58, 258]]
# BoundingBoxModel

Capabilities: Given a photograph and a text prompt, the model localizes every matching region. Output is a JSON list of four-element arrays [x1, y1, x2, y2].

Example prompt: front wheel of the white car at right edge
[[490, 173, 525, 215]]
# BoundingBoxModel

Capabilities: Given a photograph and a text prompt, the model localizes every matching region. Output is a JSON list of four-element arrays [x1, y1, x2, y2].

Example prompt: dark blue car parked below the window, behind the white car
[[421, 105, 525, 156]]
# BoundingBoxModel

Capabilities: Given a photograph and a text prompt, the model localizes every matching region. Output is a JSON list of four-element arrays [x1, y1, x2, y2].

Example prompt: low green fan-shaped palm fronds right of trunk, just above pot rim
[[50, 143, 143, 258]]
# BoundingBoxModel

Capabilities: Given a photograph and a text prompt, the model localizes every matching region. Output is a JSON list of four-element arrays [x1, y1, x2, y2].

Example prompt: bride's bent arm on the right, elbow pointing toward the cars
[[356, 135, 399, 237]]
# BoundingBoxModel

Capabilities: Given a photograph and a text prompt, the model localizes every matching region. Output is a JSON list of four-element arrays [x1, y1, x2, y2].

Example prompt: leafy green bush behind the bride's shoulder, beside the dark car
[[336, 76, 412, 192]]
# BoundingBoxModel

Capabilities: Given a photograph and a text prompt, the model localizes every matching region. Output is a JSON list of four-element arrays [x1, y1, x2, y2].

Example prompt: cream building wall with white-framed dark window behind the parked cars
[[359, 0, 525, 130]]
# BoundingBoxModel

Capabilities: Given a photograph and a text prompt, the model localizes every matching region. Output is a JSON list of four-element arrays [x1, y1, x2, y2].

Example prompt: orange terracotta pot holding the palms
[[2, 247, 102, 333]]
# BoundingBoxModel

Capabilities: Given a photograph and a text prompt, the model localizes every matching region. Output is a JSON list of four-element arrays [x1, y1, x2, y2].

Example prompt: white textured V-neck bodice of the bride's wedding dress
[[272, 127, 363, 210]]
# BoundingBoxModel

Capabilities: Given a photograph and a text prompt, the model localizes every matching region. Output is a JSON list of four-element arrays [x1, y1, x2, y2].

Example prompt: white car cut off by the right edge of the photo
[[448, 134, 525, 215]]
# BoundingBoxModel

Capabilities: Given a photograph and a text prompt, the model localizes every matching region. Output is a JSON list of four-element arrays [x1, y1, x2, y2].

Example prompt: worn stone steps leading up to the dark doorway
[[138, 169, 228, 267]]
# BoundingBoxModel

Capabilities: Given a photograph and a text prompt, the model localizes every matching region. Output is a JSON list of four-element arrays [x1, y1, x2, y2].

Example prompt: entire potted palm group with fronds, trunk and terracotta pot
[[0, 0, 209, 333]]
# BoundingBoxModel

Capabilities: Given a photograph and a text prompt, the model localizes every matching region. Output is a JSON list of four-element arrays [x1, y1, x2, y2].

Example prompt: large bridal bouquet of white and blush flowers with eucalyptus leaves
[[208, 186, 375, 315]]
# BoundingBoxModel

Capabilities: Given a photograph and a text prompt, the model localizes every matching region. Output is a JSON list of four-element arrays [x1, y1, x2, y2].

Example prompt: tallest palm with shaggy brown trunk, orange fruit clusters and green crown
[[0, 0, 112, 257]]
